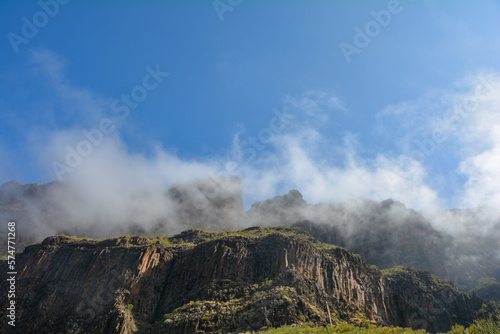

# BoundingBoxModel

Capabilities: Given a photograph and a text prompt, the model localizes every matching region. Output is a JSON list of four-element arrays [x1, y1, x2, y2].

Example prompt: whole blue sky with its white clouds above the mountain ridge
[[0, 0, 500, 208]]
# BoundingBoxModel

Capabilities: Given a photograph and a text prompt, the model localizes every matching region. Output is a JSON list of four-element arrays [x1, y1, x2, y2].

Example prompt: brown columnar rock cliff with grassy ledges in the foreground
[[0, 228, 482, 333]]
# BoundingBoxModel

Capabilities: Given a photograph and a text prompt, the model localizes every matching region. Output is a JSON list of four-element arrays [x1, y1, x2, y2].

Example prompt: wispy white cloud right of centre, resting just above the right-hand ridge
[[232, 129, 439, 208]]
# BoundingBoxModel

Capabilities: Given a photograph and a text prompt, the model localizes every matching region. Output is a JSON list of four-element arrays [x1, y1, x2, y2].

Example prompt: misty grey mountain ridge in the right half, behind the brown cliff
[[246, 190, 500, 291]]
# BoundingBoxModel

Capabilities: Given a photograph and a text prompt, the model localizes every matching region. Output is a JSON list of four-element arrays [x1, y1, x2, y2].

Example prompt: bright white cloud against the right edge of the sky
[[377, 70, 500, 207]]
